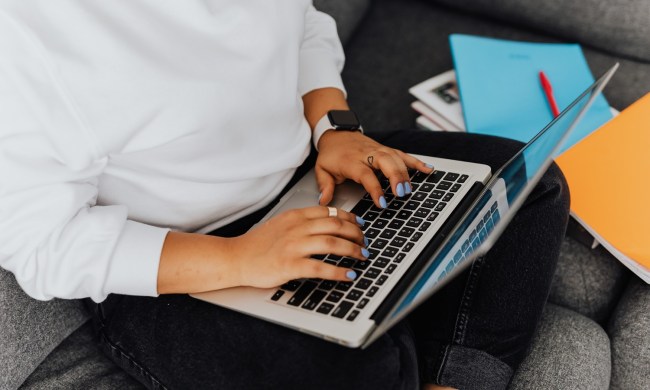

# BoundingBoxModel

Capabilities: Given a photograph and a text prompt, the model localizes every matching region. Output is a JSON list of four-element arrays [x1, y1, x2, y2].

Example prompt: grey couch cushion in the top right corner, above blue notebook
[[435, 0, 650, 62]]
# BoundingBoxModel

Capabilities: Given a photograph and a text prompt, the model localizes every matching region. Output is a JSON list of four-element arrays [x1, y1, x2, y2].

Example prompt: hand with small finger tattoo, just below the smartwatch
[[315, 131, 433, 208]]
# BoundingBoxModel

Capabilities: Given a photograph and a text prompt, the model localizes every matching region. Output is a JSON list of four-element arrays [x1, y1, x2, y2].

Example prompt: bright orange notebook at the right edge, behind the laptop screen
[[556, 93, 650, 283]]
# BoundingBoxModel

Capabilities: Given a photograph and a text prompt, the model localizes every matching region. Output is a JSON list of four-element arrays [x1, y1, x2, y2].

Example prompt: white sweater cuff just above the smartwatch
[[298, 50, 347, 96]]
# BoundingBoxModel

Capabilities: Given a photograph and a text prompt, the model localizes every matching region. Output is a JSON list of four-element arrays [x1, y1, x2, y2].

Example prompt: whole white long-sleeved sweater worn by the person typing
[[0, 0, 343, 301]]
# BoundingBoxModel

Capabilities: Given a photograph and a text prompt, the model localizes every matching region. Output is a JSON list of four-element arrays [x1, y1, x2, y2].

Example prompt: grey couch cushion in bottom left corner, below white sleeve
[[0, 269, 89, 389]]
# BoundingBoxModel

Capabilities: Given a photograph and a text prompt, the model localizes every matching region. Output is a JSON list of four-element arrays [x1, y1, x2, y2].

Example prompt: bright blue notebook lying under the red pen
[[449, 34, 612, 153]]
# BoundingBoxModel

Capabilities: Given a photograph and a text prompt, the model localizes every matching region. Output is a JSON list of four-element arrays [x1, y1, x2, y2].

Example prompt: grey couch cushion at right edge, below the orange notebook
[[609, 276, 650, 390]]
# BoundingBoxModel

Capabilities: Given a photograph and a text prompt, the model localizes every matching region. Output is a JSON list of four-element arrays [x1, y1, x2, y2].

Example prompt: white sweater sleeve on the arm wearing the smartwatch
[[298, 5, 345, 96]]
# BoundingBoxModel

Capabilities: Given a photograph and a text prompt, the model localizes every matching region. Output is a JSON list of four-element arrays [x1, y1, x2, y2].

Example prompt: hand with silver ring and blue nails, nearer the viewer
[[230, 206, 368, 288]]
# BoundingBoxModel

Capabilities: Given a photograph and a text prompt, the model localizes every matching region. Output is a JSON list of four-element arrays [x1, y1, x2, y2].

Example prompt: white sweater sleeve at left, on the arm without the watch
[[0, 10, 168, 302]]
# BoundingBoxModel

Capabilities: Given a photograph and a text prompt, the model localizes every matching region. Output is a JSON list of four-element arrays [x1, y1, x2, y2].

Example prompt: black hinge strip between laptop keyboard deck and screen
[[370, 181, 485, 324]]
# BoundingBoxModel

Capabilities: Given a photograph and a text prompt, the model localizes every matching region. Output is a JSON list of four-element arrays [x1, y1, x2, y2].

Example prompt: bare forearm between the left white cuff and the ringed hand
[[158, 232, 239, 294]]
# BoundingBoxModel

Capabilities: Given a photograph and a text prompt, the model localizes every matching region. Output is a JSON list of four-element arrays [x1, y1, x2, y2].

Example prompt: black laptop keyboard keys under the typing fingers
[[271, 171, 469, 321]]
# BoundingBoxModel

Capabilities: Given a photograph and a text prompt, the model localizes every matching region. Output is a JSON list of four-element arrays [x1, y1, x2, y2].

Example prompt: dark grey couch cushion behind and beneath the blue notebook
[[343, 0, 650, 132]]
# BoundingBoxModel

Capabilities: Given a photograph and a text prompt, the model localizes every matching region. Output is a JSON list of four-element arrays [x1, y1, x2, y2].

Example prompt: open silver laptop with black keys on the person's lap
[[192, 64, 618, 348]]
